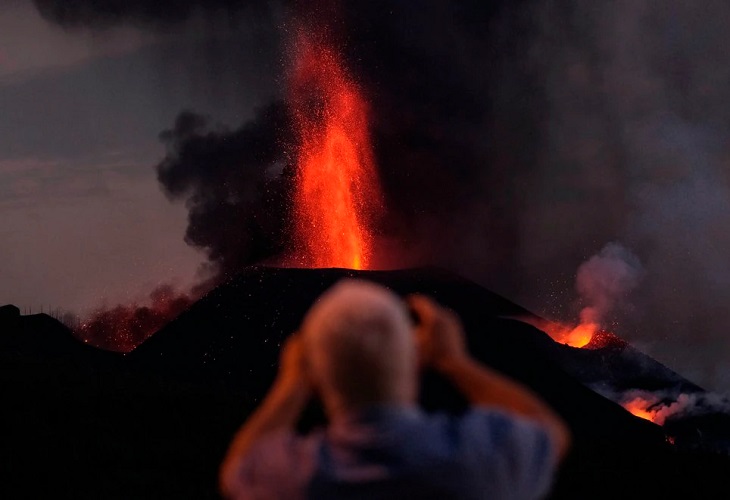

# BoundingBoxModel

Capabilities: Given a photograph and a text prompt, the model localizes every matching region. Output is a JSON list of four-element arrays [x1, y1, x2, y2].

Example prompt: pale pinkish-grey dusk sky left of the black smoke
[[0, 0, 278, 312]]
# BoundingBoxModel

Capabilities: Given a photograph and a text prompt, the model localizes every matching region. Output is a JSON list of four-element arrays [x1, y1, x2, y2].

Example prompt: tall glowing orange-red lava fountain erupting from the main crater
[[289, 30, 382, 269]]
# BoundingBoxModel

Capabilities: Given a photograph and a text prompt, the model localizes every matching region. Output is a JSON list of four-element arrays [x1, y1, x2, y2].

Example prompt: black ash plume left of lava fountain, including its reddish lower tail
[[64, 102, 291, 352]]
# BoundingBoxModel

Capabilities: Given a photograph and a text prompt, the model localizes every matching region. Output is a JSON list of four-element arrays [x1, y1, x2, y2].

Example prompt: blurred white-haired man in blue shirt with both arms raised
[[221, 280, 570, 500]]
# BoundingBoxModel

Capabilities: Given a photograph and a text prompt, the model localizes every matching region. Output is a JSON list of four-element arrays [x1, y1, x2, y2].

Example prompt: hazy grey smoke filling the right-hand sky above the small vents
[[521, 0, 730, 392]]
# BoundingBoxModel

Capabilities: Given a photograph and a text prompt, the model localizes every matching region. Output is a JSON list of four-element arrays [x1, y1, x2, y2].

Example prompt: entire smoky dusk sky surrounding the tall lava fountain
[[0, 0, 730, 393]]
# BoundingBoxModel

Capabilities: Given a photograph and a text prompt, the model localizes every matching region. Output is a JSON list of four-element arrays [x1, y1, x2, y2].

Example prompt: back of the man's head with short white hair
[[302, 279, 416, 410]]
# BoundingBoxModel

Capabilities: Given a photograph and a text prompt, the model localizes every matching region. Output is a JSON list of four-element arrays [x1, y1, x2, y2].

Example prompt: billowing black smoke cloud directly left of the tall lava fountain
[[157, 103, 291, 278]]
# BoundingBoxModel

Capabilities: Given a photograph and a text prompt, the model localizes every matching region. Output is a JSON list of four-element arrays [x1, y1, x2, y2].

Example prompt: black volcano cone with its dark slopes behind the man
[[0, 267, 730, 499]]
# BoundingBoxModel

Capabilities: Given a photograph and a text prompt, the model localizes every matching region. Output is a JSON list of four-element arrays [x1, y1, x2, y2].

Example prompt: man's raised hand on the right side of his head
[[406, 295, 469, 371]]
